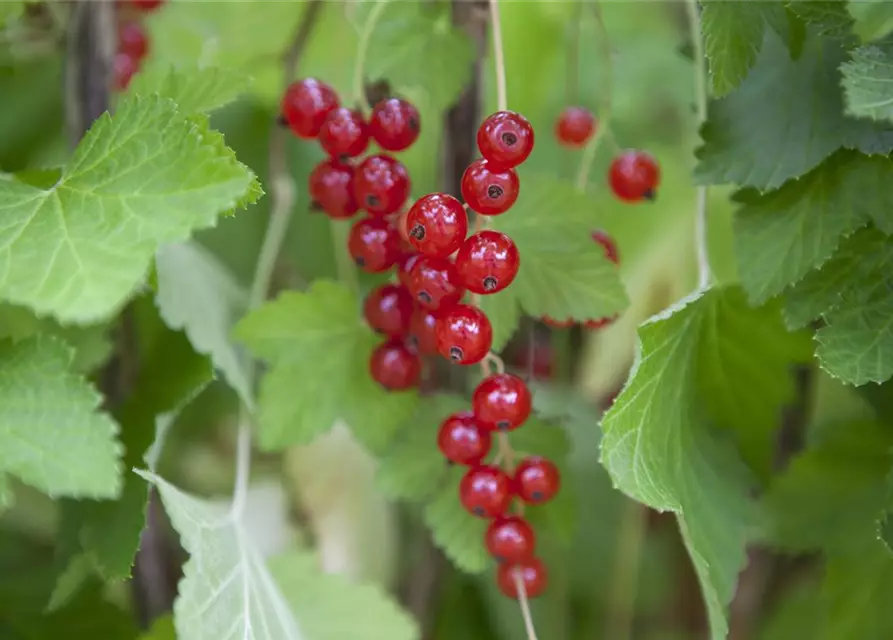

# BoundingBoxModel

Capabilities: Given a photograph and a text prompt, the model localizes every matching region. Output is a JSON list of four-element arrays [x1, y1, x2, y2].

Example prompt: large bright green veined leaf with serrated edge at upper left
[[0, 94, 255, 323]]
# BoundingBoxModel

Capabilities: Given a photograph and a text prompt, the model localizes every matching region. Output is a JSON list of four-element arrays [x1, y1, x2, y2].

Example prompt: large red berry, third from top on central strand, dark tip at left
[[406, 193, 468, 258]]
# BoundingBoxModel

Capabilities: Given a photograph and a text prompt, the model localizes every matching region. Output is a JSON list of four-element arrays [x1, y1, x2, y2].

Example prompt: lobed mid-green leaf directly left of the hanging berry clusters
[[235, 280, 417, 452]]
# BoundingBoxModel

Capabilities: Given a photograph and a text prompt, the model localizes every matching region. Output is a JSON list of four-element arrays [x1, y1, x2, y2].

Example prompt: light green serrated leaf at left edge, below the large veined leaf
[[0, 336, 121, 498]]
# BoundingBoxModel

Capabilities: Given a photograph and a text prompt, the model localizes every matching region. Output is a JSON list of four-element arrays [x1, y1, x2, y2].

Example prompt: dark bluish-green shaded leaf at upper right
[[695, 29, 893, 190]]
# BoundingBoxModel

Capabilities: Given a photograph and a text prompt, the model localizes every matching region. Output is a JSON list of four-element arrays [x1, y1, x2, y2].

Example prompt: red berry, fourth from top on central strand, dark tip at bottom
[[456, 229, 521, 295]]
